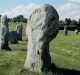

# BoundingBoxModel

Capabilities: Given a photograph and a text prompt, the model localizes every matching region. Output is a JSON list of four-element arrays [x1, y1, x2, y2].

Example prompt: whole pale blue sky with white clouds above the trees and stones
[[0, 0, 80, 20]]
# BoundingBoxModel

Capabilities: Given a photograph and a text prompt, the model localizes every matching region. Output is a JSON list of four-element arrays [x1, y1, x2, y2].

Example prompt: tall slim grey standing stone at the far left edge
[[0, 15, 10, 50]]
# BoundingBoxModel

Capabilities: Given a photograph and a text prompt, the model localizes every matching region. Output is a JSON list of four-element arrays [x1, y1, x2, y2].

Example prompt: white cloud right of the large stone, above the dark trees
[[58, 3, 80, 20]]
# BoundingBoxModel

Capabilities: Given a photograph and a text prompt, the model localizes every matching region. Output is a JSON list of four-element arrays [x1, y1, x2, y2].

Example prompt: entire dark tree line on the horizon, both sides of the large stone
[[0, 15, 80, 30]]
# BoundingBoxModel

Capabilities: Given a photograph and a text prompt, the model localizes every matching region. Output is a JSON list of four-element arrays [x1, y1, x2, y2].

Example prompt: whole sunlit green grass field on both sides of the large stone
[[0, 23, 80, 75]]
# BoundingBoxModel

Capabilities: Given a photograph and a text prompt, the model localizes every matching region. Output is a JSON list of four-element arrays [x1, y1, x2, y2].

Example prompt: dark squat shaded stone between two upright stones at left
[[8, 31, 18, 44]]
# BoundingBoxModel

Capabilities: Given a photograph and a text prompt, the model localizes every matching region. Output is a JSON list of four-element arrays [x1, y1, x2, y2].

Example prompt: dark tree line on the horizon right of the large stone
[[59, 18, 80, 30]]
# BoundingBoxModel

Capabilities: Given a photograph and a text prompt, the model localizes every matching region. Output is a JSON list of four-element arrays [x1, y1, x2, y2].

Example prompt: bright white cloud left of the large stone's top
[[2, 3, 38, 18]]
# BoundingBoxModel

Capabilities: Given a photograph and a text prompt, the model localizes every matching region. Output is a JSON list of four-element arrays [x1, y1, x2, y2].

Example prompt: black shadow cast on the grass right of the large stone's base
[[51, 64, 80, 75]]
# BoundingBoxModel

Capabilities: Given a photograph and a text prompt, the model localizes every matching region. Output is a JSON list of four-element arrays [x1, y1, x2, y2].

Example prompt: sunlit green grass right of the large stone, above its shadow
[[50, 32, 80, 70]]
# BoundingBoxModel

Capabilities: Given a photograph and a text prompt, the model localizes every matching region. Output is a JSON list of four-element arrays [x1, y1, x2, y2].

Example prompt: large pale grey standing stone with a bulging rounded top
[[24, 4, 59, 72]]
